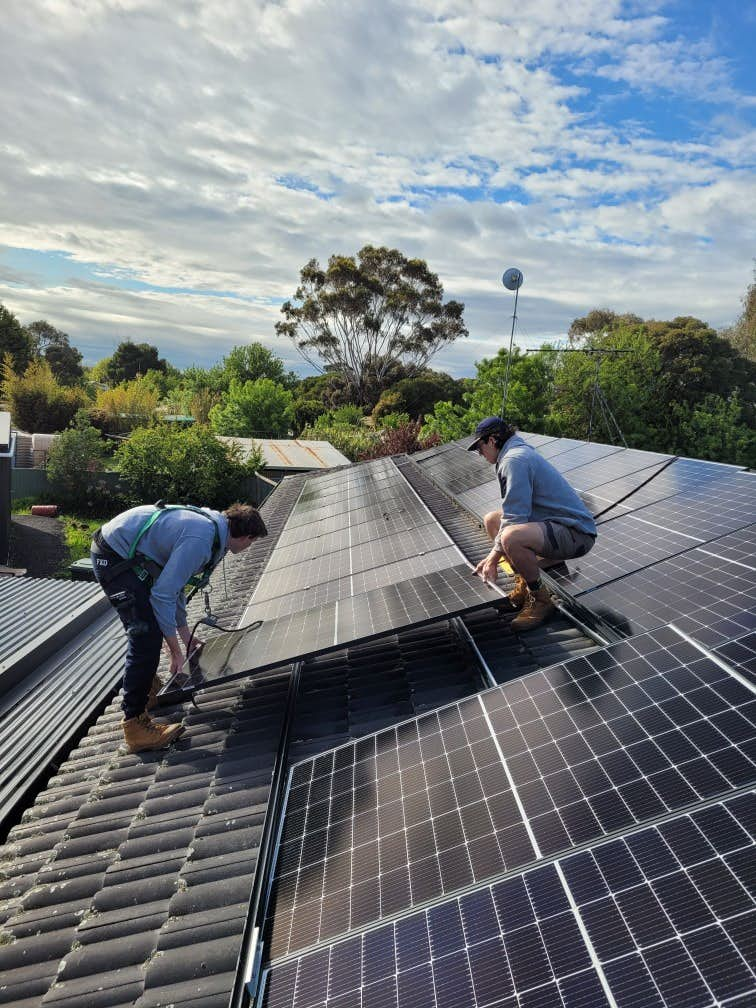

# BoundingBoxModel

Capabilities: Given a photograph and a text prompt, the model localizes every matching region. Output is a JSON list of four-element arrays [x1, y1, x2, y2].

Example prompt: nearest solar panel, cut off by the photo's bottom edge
[[263, 792, 756, 1008]]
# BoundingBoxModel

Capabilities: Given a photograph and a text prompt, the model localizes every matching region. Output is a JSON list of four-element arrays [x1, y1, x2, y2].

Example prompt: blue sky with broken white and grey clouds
[[0, 0, 756, 376]]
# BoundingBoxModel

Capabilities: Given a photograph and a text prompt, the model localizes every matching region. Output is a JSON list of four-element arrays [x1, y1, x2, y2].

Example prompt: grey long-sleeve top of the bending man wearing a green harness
[[102, 504, 229, 637]]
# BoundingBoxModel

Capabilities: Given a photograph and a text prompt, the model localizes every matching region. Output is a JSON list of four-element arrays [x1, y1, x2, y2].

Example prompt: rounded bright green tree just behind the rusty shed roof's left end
[[210, 378, 294, 437]]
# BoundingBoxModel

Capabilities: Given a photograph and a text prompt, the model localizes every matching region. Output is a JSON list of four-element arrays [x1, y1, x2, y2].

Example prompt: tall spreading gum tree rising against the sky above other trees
[[276, 245, 467, 405]]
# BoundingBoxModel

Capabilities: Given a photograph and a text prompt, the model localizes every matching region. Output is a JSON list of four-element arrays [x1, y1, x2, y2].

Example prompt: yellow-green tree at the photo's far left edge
[[2, 359, 90, 433]]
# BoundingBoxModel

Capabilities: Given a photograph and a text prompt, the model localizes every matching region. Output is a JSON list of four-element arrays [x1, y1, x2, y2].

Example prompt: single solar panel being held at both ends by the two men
[[167, 558, 501, 690]]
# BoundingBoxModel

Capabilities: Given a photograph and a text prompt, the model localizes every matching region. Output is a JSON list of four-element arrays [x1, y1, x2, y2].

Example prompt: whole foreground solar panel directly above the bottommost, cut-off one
[[270, 629, 756, 959]]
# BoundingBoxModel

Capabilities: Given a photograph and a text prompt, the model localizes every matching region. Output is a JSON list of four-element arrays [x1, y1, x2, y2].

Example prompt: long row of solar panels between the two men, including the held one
[[161, 455, 516, 691]]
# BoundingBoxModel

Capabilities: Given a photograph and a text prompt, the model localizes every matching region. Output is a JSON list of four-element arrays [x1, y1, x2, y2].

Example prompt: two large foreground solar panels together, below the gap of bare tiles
[[263, 628, 756, 1008]]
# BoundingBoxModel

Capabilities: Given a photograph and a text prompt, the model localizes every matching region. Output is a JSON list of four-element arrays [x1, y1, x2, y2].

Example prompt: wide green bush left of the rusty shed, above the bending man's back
[[116, 425, 259, 508]]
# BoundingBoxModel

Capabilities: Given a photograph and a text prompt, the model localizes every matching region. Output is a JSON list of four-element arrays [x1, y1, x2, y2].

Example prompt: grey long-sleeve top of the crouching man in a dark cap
[[496, 434, 596, 535]]
